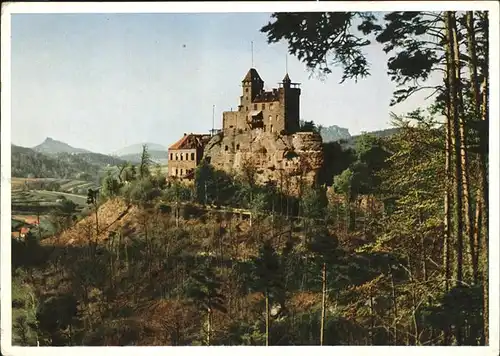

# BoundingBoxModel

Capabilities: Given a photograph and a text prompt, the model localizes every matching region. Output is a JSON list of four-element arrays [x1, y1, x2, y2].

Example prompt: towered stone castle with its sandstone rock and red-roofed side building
[[168, 68, 323, 190]]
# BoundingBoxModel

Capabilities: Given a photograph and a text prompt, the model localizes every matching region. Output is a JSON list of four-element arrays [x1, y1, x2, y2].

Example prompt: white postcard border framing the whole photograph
[[1, 1, 500, 356]]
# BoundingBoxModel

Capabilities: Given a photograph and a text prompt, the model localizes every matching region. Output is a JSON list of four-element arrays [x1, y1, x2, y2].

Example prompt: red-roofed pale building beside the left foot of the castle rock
[[168, 133, 210, 181]]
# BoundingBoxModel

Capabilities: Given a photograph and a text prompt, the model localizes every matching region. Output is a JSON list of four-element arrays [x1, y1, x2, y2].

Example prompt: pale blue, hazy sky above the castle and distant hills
[[11, 13, 442, 154]]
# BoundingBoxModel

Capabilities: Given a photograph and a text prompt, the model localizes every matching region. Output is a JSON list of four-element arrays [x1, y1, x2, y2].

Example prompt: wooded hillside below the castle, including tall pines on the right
[[12, 11, 489, 346]]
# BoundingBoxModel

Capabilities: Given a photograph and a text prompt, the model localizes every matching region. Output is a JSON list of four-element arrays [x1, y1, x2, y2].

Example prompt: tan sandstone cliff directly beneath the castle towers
[[204, 129, 323, 194]]
